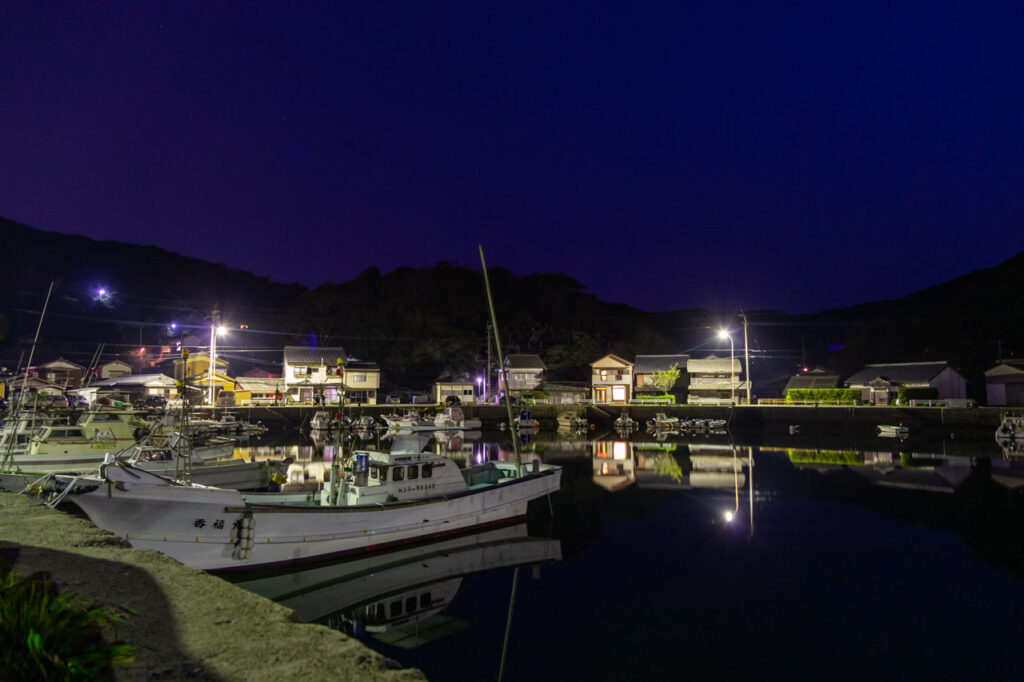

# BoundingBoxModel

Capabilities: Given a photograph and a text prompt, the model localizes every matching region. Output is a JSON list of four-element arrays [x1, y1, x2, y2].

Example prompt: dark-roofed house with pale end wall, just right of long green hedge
[[844, 360, 967, 404]]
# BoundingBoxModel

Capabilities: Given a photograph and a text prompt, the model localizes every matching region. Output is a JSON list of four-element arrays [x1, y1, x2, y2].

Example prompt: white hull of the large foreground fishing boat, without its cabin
[[68, 467, 561, 571]]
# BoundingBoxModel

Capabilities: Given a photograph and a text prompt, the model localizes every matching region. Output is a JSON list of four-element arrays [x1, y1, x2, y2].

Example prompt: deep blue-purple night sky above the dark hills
[[0, 0, 1024, 311]]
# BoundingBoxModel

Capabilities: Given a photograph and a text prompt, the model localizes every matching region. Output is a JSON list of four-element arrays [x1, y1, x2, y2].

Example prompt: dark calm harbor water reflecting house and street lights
[[226, 421, 1024, 680]]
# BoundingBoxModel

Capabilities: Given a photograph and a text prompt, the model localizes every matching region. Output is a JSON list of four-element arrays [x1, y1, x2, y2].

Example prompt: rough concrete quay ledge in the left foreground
[[0, 493, 426, 682]]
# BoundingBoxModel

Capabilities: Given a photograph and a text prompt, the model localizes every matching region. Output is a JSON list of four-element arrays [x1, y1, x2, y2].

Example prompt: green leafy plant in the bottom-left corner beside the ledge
[[0, 565, 133, 680]]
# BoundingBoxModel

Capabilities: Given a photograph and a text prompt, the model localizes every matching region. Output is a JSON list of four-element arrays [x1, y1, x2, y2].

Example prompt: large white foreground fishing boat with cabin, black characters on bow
[[56, 452, 561, 570]]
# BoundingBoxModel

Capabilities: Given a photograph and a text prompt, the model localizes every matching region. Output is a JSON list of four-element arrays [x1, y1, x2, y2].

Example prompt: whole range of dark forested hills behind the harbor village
[[0, 218, 1024, 395]]
